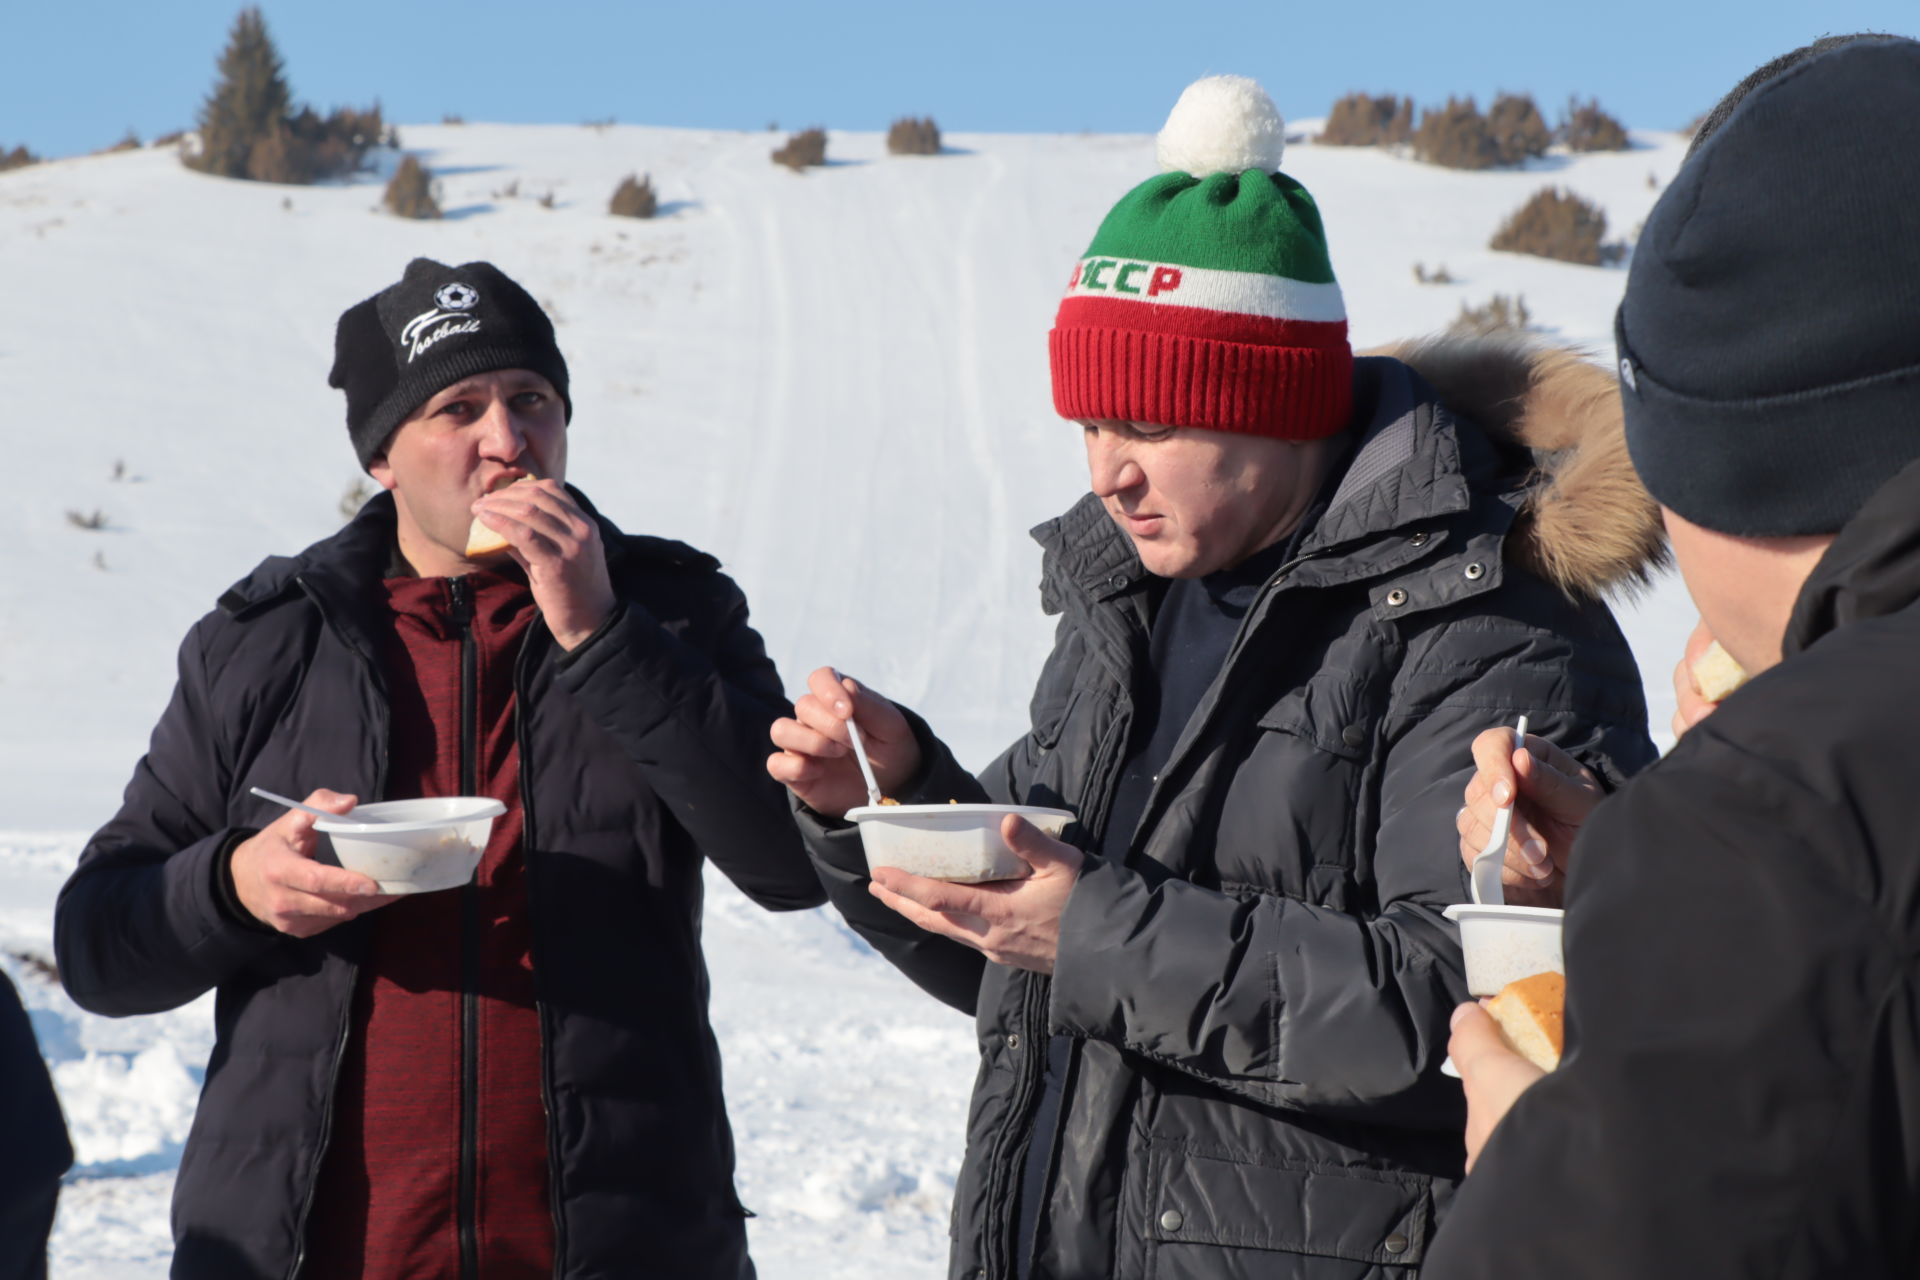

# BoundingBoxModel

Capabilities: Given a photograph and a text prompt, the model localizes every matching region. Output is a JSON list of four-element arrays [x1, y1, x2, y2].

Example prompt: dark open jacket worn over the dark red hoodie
[[54, 485, 822, 1280]]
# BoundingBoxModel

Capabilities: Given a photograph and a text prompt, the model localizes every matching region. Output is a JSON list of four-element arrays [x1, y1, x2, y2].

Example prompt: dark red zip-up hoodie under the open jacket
[[300, 574, 553, 1280]]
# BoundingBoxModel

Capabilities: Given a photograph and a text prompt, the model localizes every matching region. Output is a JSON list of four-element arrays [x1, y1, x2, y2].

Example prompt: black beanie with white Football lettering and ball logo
[[326, 257, 574, 466]]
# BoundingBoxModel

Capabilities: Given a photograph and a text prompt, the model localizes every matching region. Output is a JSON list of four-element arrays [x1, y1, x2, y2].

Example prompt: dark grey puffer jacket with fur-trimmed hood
[[804, 339, 1653, 1280]]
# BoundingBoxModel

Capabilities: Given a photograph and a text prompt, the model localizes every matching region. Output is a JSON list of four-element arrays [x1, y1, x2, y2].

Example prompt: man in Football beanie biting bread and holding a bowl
[[56, 259, 822, 1280]]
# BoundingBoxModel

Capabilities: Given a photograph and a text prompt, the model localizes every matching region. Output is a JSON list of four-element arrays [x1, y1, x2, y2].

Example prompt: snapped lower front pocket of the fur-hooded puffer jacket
[[1142, 1146, 1432, 1280]]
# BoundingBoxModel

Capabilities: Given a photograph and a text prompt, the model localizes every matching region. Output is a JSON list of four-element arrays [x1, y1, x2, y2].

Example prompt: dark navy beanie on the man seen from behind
[[1615, 38, 1920, 537]]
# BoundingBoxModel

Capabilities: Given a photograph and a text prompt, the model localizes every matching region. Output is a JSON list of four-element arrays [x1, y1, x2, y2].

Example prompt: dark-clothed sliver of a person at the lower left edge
[[0, 973, 73, 1280]]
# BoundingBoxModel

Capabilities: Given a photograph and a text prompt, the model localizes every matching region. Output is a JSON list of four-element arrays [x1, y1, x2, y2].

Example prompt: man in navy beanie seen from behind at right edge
[[1427, 36, 1920, 1280]]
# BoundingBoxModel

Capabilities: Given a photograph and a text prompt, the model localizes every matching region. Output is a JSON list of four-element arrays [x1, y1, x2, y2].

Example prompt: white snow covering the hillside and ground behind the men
[[0, 125, 1692, 1280]]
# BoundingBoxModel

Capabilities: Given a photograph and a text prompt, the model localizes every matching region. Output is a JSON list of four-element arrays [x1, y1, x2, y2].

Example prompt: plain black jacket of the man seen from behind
[[1432, 454, 1920, 1280]]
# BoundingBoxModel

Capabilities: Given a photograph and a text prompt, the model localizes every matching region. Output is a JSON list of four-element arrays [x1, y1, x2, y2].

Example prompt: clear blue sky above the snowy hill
[[0, 0, 1920, 155]]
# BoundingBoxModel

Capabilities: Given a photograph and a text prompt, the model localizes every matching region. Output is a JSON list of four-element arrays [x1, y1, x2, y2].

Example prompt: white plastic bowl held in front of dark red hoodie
[[313, 796, 507, 894]]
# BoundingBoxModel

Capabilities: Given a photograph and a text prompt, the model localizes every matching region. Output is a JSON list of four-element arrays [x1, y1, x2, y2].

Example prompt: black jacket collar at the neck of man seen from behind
[[1782, 462, 1920, 658]]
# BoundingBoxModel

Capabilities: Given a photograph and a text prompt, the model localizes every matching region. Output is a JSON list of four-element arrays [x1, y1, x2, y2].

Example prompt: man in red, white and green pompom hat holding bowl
[[768, 77, 1657, 1280]]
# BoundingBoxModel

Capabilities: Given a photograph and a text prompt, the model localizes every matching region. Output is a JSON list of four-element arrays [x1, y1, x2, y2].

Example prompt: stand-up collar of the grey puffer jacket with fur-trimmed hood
[[1033, 357, 1503, 614]]
